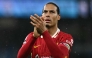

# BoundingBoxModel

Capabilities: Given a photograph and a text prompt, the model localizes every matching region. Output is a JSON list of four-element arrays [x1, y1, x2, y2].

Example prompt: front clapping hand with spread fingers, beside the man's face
[[30, 14, 47, 34]]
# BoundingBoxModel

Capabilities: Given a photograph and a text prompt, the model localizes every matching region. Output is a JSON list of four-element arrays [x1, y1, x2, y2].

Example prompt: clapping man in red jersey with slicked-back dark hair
[[17, 2, 73, 58]]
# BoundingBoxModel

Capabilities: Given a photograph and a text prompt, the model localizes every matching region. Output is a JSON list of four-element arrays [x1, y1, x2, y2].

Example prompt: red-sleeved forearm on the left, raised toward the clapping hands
[[17, 36, 36, 58]]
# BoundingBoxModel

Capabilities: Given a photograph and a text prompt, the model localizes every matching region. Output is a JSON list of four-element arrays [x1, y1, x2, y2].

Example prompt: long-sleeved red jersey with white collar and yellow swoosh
[[17, 29, 73, 58]]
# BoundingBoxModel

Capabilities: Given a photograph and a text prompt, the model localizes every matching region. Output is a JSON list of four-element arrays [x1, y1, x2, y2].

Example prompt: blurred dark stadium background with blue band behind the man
[[0, 0, 92, 58]]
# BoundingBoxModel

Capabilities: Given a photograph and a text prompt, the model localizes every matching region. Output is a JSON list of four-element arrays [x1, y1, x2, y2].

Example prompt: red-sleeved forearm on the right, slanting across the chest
[[43, 31, 68, 58]]
